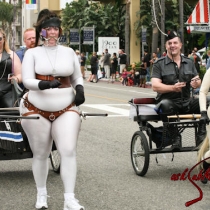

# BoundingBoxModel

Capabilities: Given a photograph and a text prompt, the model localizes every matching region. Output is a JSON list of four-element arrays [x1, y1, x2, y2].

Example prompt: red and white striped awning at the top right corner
[[185, 0, 209, 25]]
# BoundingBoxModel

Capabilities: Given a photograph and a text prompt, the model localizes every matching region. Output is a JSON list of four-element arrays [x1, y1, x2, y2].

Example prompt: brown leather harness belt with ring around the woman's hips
[[23, 96, 75, 121]]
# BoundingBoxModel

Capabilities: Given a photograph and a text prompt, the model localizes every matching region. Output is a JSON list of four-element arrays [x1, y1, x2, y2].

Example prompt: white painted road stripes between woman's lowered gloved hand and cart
[[82, 104, 130, 117]]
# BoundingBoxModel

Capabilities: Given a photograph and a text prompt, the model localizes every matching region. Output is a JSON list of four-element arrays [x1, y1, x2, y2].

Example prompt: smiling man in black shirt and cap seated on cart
[[152, 31, 206, 150]]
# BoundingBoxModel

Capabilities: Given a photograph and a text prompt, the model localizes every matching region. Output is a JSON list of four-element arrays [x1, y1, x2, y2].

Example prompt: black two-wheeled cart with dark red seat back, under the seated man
[[129, 98, 200, 176]]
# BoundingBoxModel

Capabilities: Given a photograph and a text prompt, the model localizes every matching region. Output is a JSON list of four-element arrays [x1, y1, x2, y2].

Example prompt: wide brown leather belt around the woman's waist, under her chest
[[36, 74, 71, 88]]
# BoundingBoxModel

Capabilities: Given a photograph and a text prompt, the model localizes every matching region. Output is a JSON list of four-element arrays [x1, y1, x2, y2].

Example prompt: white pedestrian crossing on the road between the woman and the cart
[[81, 104, 130, 117]]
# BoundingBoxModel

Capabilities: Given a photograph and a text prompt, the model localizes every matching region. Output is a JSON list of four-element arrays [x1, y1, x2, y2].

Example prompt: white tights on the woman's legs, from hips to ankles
[[21, 111, 81, 193]]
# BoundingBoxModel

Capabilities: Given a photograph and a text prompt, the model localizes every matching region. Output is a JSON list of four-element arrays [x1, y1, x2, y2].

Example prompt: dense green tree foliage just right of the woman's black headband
[[62, 0, 125, 52]]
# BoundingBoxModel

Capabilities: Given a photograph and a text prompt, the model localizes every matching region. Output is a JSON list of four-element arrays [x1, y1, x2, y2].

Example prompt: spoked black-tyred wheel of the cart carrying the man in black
[[131, 131, 150, 176]]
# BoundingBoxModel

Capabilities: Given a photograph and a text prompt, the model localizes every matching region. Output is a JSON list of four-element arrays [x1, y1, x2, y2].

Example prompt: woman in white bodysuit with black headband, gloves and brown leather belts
[[20, 13, 85, 210]]
